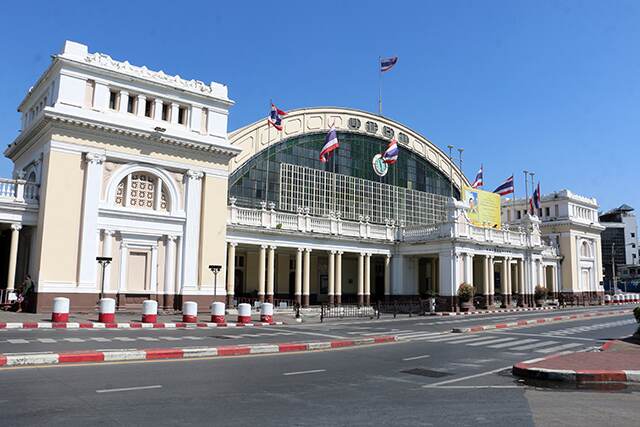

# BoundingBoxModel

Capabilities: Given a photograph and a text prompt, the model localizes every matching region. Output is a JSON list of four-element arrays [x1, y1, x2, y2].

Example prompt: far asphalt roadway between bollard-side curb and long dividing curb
[[0, 307, 633, 354]]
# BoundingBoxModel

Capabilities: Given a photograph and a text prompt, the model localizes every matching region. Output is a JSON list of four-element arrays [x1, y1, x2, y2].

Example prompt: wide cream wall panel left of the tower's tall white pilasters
[[36, 151, 84, 284]]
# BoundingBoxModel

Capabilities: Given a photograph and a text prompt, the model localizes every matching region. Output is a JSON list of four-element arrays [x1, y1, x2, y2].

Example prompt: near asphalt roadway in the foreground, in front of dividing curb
[[0, 306, 640, 427]]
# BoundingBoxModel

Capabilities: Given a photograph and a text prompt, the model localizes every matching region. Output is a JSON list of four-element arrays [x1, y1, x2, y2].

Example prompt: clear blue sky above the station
[[0, 0, 640, 209]]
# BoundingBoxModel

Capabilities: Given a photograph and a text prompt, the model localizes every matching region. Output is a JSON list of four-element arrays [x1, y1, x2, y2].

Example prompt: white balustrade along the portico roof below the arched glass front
[[227, 198, 547, 247]]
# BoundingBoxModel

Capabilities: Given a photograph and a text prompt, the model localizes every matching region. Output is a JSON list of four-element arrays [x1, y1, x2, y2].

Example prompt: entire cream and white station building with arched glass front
[[0, 41, 603, 311]]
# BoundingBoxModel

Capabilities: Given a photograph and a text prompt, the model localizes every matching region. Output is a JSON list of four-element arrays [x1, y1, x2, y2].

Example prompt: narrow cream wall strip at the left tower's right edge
[[199, 175, 228, 287]]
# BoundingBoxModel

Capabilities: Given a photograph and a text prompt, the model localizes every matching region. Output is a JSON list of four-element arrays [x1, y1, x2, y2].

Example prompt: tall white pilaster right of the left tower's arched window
[[182, 170, 203, 291]]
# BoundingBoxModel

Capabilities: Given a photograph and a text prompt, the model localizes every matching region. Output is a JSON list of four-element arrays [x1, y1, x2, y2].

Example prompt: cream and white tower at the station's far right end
[[502, 190, 604, 301]]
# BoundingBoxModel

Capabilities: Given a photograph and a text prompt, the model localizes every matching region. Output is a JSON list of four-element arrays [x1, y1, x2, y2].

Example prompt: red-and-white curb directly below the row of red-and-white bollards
[[0, 322, 284, 329]]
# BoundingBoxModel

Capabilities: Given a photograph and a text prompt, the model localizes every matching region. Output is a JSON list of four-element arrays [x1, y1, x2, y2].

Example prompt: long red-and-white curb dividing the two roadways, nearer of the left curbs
[[0, 335, 398, 366]]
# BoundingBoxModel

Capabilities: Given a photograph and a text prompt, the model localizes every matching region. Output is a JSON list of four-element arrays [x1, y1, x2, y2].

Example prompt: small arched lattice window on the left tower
[[115, 172, 169, 212]]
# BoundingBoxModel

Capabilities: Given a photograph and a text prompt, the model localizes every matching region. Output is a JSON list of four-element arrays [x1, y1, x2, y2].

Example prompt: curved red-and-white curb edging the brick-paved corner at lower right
[[511, 352, 640, 383]]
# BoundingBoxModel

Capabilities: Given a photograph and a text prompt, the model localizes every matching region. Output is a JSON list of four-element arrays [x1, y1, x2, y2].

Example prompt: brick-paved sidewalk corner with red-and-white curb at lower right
[[512, 337, 640, 384]]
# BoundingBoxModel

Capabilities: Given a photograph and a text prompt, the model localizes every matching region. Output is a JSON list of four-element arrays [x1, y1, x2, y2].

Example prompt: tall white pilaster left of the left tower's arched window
[[78, 153, 106, 289]]
